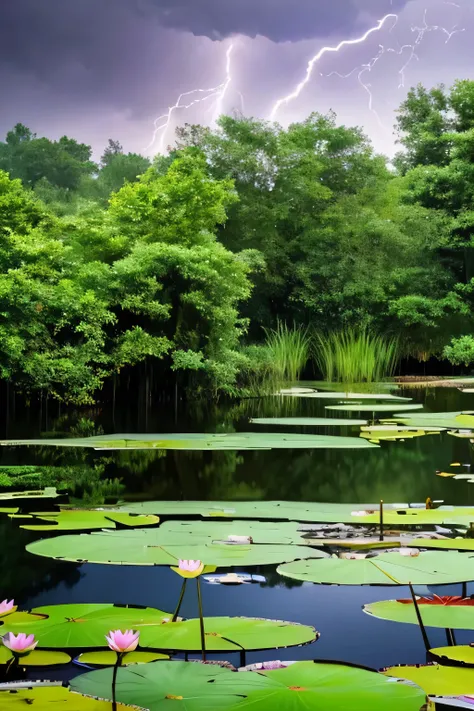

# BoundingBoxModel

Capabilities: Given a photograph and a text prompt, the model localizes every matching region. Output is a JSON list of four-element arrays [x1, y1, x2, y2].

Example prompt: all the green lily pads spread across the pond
[[0, 388, 474, 711]]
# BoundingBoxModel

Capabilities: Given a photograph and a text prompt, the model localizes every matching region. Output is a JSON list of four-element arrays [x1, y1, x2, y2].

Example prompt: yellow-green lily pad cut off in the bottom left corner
[[0, 686, 141, 711]]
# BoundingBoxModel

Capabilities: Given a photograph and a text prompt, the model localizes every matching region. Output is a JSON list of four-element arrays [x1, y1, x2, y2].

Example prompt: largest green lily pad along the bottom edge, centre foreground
[[71, 662, 425, 711]]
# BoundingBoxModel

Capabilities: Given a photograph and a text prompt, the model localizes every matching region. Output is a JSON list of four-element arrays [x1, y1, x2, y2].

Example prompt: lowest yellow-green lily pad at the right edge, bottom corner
[[384, 664, 474, 696]]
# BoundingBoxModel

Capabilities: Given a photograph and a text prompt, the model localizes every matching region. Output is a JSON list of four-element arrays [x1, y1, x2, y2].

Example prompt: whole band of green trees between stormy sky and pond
[[0, 80, 474, 404]]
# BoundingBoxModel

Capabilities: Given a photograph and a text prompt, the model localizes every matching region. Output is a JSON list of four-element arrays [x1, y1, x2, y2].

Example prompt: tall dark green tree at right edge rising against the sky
[[397, 80, 474, 354]]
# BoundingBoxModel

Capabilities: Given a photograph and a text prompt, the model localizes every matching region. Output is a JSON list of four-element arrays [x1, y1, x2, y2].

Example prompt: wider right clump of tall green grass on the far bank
[[313, 328, 401, 383]]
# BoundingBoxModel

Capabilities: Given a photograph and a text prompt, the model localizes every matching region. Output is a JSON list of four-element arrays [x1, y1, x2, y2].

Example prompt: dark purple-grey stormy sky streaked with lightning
[[0, 0, 474, 161]]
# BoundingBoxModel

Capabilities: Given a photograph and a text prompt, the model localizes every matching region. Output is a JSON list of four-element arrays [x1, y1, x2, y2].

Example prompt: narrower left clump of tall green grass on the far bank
[[265, 321, 311, 382]]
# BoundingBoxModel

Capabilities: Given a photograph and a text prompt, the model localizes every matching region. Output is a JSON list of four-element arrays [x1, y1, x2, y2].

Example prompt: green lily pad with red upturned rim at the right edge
[[362, 597, 474, 630]]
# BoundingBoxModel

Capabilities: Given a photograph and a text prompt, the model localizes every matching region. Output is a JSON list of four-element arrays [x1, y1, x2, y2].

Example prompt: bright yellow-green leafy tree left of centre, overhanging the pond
[[110, 149, 251, 389]]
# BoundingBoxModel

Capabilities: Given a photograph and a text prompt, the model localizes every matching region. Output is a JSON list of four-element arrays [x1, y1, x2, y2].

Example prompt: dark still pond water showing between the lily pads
[[0, 388, 474, 678]]
